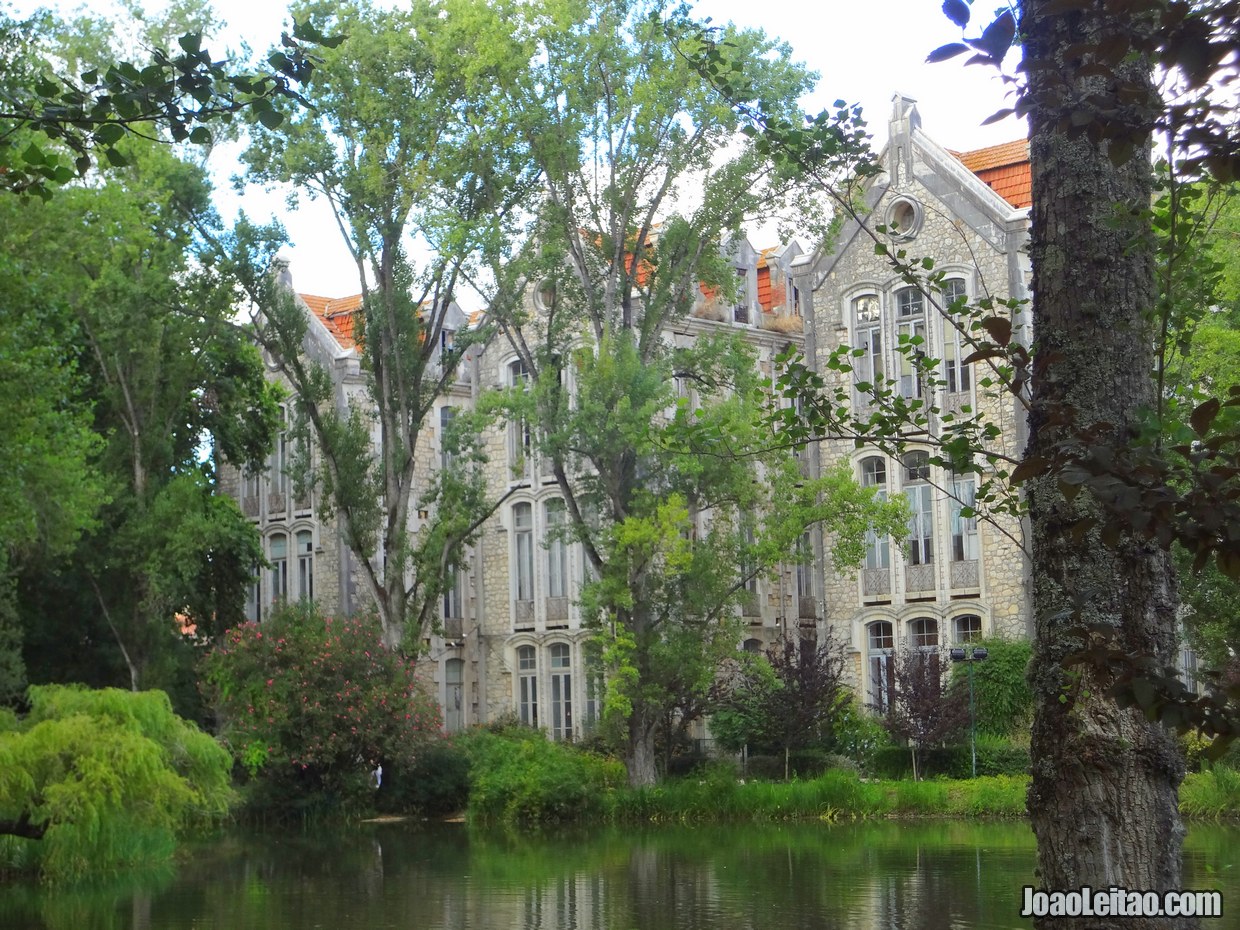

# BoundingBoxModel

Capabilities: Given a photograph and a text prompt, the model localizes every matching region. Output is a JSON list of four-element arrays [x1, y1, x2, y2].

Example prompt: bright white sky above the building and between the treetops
[[10, 0, 1025, 296]]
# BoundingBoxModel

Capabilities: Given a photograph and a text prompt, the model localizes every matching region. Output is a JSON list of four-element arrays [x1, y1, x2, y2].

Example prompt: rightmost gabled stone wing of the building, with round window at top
[[799, 95, 1030, 708]]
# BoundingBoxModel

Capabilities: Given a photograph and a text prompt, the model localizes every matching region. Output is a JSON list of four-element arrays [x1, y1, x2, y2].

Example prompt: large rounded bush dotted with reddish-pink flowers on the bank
[[203, 603, 440, 812]]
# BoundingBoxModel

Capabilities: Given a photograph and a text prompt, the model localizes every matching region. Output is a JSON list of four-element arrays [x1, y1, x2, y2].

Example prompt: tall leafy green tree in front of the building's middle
[[491, 1, 898, 785]]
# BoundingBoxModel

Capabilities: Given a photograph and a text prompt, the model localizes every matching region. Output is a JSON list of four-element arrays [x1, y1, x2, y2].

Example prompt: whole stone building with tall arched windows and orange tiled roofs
[[221, 97, 1029, 739]]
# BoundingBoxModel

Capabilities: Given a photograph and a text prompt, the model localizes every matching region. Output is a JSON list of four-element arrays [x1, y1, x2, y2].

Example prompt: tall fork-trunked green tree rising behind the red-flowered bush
[[236, 0, 538, 651]]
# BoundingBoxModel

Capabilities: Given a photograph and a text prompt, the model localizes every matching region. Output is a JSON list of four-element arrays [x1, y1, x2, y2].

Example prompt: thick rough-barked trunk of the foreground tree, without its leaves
[[1022, 0, 1192, 930]]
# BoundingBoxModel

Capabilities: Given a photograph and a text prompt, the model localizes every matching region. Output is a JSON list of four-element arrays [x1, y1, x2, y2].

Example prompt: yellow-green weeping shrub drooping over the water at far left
[[0, 686, 232, 879]]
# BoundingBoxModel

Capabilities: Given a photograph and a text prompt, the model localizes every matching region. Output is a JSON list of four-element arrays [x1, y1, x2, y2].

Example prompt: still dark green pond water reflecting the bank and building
[[7, 821, 1240, 930]]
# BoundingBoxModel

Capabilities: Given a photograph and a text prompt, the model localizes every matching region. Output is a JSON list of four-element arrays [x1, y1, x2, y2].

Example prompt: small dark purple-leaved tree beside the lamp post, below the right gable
[[883, 649, 968, 779]]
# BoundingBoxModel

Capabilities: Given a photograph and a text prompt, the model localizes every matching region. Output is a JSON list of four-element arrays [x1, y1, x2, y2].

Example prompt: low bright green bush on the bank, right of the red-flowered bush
[[458, 728, 624, 823]]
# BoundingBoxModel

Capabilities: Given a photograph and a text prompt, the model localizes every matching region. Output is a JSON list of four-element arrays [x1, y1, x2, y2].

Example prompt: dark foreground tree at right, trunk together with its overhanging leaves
[[684, 0, 1240, 928]]
